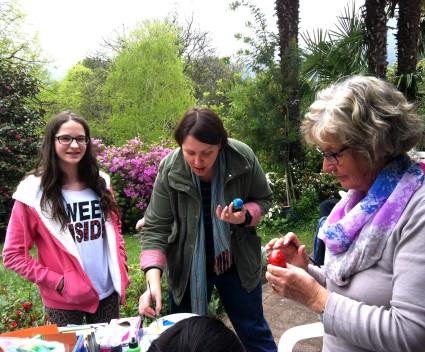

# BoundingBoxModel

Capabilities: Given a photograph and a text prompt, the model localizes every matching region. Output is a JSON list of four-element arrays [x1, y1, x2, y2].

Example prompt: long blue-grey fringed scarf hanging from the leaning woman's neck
[[190, 150, 232, 315]]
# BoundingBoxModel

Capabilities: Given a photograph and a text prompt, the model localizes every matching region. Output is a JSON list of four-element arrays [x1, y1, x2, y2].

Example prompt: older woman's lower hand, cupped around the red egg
[[266, 264, 329, 313]]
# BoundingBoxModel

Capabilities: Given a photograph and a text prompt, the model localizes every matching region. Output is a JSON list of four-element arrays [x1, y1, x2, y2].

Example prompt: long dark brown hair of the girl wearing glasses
[[31, 111, 119, 229]]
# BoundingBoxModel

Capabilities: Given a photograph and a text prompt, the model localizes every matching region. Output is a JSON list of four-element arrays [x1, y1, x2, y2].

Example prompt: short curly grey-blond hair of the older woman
[[301, 76, 423, 163]]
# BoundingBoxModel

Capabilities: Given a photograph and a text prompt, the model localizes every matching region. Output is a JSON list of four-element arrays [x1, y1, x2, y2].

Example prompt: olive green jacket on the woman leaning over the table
[[141, 139, 272, 304]]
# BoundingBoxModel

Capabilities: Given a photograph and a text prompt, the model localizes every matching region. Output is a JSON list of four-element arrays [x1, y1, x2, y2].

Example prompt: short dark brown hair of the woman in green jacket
[[174, 108, 227, 147]]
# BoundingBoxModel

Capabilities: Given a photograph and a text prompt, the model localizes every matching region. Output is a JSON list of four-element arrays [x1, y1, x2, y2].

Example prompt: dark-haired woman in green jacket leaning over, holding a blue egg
[[139, 108, 277, 351]]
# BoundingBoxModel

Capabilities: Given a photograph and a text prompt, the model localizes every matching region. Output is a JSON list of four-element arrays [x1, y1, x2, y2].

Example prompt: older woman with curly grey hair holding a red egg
[[266, 76, 425, 352]]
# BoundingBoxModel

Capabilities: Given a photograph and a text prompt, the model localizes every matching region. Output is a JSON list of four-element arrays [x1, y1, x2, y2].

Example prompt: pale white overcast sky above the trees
[[20, 0, 364, 78]]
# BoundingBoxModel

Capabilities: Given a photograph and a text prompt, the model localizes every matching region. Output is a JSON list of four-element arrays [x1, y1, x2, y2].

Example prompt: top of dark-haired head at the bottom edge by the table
[[148, 316, 245, 352]]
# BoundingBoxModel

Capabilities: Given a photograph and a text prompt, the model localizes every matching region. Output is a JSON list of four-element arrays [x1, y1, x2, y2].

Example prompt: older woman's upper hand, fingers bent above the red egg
[[265, 232, 308, 270]]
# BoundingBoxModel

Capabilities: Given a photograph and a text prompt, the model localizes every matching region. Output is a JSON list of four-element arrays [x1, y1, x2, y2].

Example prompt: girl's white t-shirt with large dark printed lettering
[[62, 188, 114, 299]]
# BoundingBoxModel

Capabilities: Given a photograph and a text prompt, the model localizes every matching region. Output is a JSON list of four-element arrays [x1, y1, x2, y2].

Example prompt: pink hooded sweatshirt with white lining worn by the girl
[[3, 173, 129, 313]]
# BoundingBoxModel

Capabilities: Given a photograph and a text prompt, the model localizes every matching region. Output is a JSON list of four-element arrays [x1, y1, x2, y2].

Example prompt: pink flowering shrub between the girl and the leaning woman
[[93, 137, 172, 231]]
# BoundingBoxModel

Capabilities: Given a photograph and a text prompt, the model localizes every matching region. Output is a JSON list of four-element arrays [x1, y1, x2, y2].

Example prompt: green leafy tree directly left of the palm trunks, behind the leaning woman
[[229, 0, 288, 171]]
